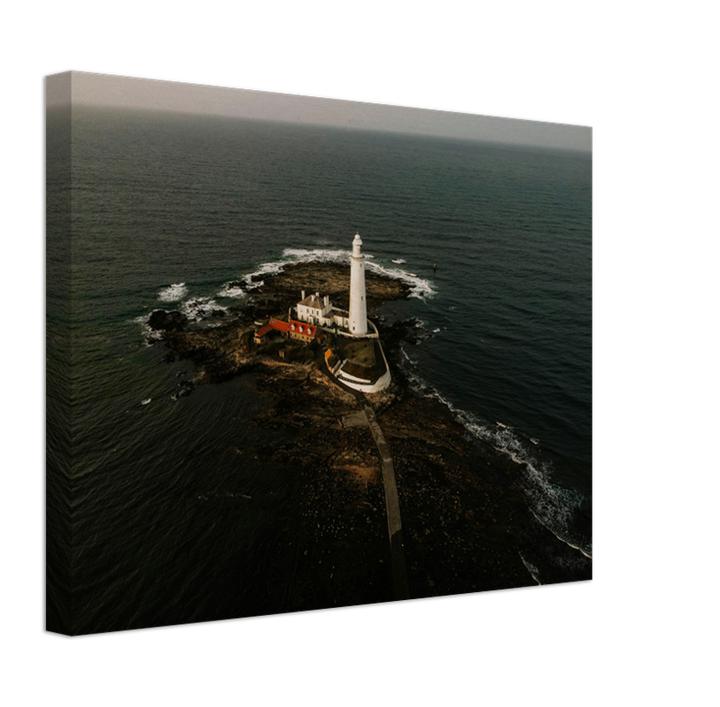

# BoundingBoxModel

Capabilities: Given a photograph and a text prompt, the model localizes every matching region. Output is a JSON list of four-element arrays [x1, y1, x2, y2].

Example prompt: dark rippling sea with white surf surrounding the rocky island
[[45, 105, 594, 634]]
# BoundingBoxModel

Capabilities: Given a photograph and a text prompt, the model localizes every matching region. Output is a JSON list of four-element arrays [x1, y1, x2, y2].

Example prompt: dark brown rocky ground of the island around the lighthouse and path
[[150, 263, 587, 615]]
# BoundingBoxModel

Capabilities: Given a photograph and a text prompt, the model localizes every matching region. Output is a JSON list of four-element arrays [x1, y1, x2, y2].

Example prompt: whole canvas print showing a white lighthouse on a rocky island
[[46, 70, 594, 635]]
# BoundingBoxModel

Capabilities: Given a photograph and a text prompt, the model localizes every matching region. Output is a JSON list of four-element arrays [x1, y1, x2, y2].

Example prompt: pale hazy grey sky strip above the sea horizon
[[46, 71, 593, 152]]
